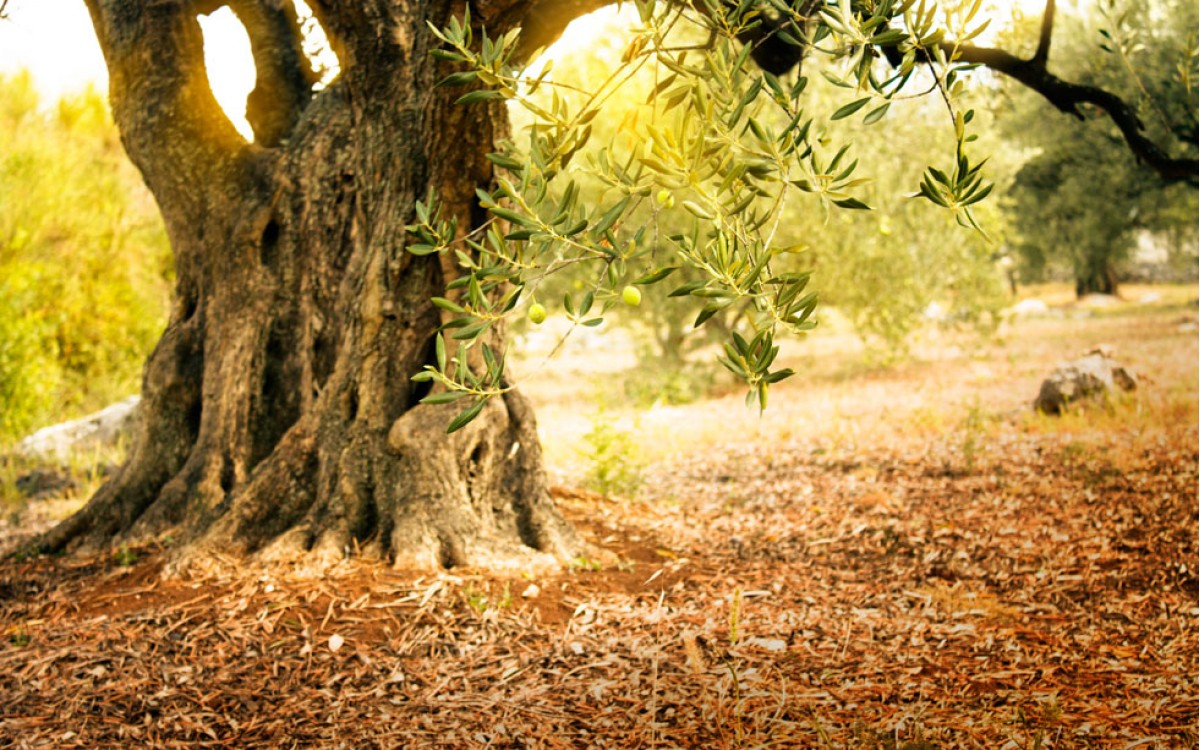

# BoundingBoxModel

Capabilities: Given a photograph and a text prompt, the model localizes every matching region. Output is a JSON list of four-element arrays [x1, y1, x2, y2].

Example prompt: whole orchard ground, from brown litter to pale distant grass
[[0, 284, 1200, 749]]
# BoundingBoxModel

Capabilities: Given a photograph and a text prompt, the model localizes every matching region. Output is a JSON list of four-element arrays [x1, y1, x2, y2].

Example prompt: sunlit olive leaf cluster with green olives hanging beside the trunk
[[408, 0, 991, 432]]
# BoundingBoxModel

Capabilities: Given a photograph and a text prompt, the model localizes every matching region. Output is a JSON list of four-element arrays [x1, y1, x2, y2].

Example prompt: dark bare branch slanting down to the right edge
[[942, 42, 1200, 185]]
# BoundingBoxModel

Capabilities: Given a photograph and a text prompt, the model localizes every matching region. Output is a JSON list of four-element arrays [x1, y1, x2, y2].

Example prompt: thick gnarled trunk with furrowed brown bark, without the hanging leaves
[[42, 0, 592, 566]]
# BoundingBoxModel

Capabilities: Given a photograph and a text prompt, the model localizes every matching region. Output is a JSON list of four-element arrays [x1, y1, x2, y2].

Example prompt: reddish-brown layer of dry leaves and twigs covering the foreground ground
[[0, 439, 1196, 748]]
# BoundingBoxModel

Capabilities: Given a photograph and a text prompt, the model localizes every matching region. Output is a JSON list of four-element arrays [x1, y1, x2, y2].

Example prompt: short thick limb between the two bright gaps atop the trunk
[[229, 0, 317, 146]]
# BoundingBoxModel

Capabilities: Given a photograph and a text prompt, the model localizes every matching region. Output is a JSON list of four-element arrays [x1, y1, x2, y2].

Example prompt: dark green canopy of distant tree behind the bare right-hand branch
[[1000, 0, 1198, 295]]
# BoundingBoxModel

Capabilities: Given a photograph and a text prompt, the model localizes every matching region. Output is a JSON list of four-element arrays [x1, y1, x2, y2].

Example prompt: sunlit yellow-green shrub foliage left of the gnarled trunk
[[0, 73, 172, 443]]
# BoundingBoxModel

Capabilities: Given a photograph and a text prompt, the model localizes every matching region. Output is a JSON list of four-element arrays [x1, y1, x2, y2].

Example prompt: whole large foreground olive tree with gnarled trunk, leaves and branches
[[30, 0, 1195, 566]]
